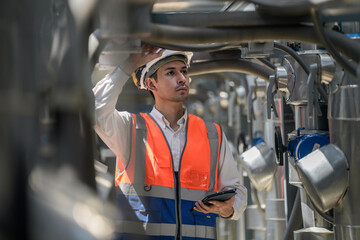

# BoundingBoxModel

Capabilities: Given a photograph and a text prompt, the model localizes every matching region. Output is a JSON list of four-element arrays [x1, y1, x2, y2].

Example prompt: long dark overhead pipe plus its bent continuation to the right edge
[[142, 24, 360, 62]]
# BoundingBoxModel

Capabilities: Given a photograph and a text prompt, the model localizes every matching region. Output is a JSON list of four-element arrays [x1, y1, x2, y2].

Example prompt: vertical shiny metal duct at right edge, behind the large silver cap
[[328, 85, 360, 240]]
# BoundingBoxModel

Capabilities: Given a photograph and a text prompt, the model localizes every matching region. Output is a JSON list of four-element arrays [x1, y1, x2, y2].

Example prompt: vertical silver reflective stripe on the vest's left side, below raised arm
[[134, 114, 147, 191]]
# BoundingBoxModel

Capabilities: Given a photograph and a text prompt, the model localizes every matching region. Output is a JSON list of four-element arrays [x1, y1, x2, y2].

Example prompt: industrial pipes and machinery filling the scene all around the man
[[0, 0, 360, 240]]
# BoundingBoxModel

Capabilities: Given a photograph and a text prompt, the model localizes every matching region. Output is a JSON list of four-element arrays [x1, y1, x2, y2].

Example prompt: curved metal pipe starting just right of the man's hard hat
[[189, 59, 274, 81]]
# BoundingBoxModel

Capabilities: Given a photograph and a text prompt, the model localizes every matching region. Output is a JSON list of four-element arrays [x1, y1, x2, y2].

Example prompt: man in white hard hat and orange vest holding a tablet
[[93, 45, 247, 240]]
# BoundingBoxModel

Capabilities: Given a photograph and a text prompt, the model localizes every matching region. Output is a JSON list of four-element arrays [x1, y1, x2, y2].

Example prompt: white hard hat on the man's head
[[132, 50, 193, 89]]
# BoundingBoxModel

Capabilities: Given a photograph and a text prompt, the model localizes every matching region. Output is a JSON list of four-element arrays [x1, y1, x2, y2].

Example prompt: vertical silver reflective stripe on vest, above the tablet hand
[[205, 122, 219, 192]]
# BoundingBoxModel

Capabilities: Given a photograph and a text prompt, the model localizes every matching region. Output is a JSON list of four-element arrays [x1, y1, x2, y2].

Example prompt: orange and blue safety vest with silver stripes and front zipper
[[115, 113, 221, 239]]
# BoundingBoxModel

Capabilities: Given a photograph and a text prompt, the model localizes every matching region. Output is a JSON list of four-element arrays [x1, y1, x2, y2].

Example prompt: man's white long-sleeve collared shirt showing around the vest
[[93, 67, 247, 220]]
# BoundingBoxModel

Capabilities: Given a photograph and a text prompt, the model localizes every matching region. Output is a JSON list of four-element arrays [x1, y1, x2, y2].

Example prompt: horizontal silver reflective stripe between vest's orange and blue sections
[[119, 183, 213, 202]]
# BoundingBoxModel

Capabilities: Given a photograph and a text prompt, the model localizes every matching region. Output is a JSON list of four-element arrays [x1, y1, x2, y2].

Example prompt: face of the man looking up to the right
[[153, 61, 189, 102]]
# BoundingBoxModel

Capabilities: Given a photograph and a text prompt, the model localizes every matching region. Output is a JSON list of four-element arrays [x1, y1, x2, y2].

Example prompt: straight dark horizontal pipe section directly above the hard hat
[[142, 24, 320, 44]]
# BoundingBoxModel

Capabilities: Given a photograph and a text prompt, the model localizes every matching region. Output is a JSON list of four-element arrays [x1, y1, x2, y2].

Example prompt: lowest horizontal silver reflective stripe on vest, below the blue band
[[116, 221, 216, 239]]
